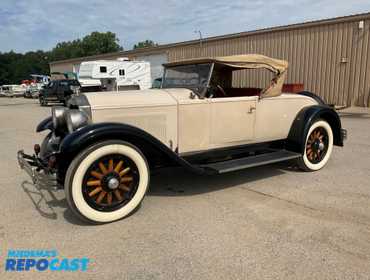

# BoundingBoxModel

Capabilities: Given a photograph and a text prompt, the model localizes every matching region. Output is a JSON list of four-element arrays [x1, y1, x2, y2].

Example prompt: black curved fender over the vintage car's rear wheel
[[287, 105, 343, 153]]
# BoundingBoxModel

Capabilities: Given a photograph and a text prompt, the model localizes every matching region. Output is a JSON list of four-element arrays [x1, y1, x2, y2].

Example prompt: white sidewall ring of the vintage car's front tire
[[70, 144, 149, 223]]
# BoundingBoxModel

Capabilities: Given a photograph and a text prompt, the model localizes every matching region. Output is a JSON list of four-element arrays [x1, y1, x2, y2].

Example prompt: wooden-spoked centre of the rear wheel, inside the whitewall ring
[[306, 127, 329, 164]]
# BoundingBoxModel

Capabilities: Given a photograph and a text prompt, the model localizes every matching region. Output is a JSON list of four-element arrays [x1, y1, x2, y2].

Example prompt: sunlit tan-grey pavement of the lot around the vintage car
[[0, 98, 370, 280]]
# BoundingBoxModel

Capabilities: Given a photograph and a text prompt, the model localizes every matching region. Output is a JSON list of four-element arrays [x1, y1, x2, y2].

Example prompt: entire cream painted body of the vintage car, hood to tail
[[86, 89, 317, 154]]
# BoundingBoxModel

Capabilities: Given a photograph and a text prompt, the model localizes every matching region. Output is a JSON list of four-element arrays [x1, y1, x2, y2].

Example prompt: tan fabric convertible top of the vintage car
[[164, 54, 288, 97]]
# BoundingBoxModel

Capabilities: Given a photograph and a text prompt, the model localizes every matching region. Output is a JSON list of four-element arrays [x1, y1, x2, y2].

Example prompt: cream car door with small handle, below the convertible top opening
[[210, 96, 258, 148]]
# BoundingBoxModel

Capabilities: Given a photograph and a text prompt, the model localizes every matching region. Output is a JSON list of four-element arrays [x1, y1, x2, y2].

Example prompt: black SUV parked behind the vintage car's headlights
[[39, 80, 81, 106]]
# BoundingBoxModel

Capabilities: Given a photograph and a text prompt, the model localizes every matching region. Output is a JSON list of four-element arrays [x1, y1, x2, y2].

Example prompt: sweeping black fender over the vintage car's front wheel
[[59, 123, 204, 173]]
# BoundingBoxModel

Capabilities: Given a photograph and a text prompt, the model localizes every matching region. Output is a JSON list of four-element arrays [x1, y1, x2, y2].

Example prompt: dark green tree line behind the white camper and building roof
[[0, 32, 157, 85]]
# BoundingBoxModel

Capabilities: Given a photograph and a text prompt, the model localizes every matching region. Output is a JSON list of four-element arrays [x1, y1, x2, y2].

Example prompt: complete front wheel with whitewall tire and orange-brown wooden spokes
[[65, 141, 150, 224]]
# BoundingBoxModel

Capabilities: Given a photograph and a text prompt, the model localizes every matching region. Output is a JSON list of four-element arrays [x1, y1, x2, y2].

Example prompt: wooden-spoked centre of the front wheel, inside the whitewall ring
[[82, 154, 140, 211]]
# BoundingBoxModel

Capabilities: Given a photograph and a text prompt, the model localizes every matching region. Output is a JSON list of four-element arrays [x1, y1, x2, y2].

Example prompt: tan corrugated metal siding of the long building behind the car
[[169, 17, 370, 106]]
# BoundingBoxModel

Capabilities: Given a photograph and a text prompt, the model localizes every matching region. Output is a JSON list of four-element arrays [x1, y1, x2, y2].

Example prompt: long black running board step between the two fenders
[[200, 150, 301, 173]]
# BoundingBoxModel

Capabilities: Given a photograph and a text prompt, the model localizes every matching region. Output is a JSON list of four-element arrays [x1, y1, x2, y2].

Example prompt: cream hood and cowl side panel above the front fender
[[85, 90, 178, 151]]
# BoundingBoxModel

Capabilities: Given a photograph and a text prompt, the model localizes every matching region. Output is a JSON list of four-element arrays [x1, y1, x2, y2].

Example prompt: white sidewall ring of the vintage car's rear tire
[[303, 121, 334, 171]]
